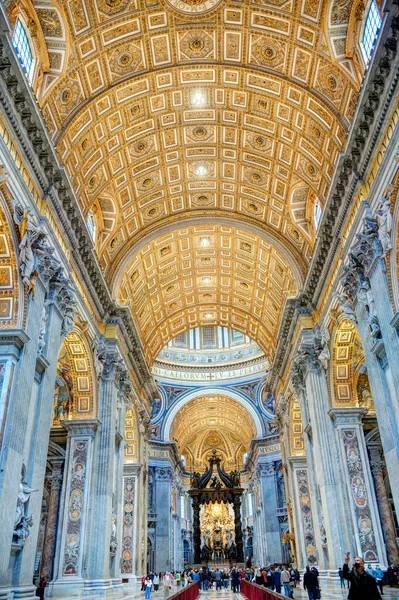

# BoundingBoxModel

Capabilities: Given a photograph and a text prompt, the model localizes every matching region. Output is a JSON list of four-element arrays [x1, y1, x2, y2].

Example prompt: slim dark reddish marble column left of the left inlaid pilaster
[[40, 459, 64, 580]]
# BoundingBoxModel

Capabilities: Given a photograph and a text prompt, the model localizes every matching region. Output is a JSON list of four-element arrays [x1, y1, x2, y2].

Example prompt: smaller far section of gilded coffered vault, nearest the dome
[[117, 225, 298, 363]]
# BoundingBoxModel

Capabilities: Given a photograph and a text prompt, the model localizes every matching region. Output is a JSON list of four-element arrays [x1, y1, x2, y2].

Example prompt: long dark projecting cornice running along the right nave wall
[[268, 0, 399, 391]]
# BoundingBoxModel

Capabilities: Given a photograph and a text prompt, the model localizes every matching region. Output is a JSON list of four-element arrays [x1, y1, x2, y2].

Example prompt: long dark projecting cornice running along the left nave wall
[[0, 7, 156, 397]]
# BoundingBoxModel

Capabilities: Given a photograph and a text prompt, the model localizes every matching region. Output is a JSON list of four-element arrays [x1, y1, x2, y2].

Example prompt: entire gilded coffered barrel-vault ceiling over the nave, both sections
[[8, 0, 374, 364]]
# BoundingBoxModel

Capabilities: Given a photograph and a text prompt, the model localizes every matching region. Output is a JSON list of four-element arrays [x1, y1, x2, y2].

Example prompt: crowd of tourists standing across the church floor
[[141, 555, 399, 600]]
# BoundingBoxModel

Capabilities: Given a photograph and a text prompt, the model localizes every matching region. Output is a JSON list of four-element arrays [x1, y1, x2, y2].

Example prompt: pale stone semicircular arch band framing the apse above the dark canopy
[[161, 387, 264, 441]]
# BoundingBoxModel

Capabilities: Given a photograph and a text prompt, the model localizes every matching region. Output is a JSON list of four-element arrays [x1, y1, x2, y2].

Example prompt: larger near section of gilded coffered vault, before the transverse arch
[[36, 0, 359, 281]]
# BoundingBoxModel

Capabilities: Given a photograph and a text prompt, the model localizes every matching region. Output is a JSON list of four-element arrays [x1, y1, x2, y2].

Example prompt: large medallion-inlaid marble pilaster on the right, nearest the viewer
[[330, 408, 387, 569]]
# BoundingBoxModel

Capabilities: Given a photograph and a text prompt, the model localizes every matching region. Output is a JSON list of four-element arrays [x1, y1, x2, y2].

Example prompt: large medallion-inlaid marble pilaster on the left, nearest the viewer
[[47, 419, 100, 598]]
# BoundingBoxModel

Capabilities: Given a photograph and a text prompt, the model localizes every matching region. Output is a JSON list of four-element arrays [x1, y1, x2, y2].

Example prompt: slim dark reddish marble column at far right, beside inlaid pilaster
[[369, 446, 399, 565]]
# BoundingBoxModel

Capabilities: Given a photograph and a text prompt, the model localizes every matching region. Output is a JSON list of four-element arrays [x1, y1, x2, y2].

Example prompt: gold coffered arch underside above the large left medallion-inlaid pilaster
[[53, 326, 97, 425]]
